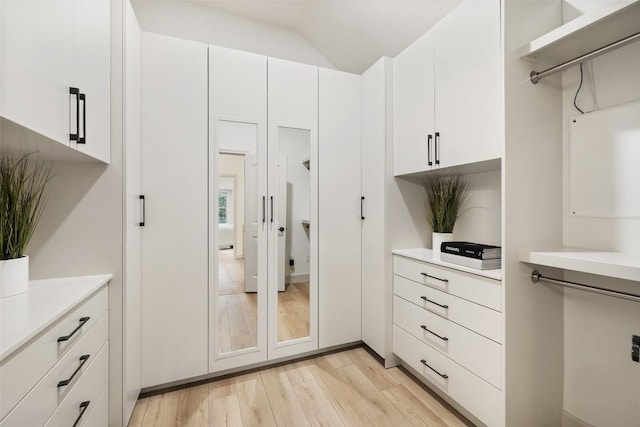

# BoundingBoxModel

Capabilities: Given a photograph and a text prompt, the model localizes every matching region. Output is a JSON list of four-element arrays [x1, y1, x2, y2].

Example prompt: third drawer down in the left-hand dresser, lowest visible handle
[[45, 343, 109, 427]]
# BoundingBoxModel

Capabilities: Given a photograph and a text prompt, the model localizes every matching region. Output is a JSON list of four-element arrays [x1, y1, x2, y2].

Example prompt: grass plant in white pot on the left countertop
[[0, 154, 51, 298]]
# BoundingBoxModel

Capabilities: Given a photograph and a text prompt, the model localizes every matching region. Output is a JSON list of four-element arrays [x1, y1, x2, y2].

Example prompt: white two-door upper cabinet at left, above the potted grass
[[0, 0, 111, 163]]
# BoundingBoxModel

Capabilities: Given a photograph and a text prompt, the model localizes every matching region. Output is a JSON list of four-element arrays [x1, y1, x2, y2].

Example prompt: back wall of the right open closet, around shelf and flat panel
[[562, 0, 640, 426]]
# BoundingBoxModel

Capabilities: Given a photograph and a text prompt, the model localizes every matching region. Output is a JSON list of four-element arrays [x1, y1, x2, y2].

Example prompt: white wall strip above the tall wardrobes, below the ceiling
[[127, 0, 334, 68]]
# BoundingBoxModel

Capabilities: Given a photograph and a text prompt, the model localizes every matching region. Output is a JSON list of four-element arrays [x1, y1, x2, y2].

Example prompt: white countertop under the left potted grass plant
[[0, 274, 113, 361]]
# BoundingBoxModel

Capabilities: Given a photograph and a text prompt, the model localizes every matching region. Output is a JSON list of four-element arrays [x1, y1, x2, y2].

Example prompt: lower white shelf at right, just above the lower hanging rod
[[519, 247, 640, 282]]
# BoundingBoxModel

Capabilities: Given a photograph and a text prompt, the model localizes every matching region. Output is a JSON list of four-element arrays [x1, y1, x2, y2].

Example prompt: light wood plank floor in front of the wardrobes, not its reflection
[[129, 348, 471, 427]]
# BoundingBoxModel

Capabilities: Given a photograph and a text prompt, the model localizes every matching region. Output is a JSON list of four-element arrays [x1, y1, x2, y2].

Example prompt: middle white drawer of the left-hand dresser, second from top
[[0, 312, 109, 427]]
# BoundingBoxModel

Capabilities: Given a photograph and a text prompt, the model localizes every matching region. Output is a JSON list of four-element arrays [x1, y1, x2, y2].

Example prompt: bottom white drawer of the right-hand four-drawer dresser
[[393, 326, 504, 426]]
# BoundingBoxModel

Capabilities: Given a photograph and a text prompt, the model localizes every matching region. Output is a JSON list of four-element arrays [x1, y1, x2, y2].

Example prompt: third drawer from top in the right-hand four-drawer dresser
[[393, 296, 502, 389]]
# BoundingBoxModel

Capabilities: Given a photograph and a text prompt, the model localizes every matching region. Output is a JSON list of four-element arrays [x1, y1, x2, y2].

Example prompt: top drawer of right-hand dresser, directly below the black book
[[393, 255, 502, 311]]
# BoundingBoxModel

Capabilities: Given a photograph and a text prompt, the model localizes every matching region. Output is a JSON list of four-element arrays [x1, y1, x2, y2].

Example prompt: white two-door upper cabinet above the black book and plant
[[394, 0, 502, 176]]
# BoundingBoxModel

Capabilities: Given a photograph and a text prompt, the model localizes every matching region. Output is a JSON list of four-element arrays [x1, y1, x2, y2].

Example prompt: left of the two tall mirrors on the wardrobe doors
[[216, 120, 263, 354]]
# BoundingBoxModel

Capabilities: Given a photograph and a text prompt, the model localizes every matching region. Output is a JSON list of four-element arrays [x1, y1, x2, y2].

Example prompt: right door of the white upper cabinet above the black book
[[434, 0, 503, 167]]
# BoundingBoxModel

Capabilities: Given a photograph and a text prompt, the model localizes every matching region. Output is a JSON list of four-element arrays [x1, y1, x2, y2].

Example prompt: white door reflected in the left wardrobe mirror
[[244, 154, 258, 292]]
